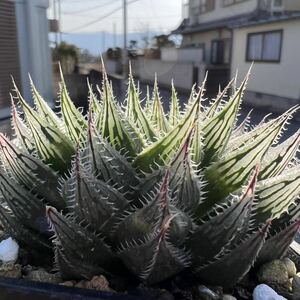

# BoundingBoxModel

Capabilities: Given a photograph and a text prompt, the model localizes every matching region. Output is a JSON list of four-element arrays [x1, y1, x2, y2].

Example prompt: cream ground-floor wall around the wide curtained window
[[231, 20, 300, 108]]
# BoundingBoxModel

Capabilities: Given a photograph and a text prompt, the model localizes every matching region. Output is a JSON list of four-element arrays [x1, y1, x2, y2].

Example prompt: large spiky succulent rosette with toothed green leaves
[[0, 65, 300, 287]]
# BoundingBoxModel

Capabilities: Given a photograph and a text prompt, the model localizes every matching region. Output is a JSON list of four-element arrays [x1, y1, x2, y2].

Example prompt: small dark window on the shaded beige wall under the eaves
[[211, 39, 230, 65]]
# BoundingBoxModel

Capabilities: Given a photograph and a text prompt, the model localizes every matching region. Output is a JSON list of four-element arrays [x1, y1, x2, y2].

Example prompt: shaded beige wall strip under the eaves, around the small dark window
[[182, 29, 231, 64]]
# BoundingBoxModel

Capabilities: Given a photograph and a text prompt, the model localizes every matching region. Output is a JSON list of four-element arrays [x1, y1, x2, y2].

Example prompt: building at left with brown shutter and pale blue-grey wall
[[0, 0, 52, 119]]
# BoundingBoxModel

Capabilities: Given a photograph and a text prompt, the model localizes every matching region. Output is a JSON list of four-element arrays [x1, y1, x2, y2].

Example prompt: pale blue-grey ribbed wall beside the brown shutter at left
[[15, 0, 52, 101]]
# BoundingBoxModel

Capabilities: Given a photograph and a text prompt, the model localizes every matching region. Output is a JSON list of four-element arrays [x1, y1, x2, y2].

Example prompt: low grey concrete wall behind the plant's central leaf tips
[[135, 58, 205, 90]]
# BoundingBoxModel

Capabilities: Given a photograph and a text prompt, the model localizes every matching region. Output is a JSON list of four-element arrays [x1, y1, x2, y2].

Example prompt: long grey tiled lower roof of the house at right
[[172, 10, 300, 34]]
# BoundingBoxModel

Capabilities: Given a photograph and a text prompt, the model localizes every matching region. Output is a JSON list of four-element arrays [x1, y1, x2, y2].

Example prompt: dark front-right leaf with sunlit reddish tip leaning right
[[187, 170, 258, 265]]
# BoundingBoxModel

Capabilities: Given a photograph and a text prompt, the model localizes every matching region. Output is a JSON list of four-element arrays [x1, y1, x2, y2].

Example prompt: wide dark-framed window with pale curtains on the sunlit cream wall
[[246, 30, 282, 62]]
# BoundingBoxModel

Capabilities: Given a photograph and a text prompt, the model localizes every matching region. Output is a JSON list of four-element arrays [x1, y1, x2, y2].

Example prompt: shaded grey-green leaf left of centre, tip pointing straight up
[[62, 153, 128, 234]]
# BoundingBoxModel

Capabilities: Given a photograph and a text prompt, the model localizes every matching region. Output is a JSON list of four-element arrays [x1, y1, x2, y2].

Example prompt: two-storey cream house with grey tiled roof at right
[[173, 0, 300, 111]]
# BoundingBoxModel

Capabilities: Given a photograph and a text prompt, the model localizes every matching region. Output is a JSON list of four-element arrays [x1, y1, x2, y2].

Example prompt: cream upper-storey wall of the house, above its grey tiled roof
[[189, 0, 259, 23]]
